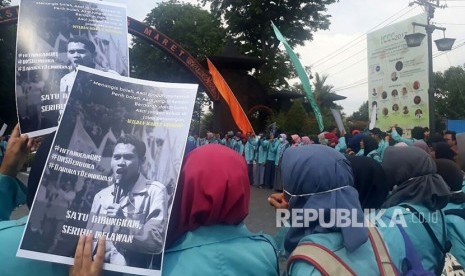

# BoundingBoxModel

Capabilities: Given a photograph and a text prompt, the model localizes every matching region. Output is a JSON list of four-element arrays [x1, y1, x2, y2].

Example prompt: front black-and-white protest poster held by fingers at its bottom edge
[[18, 66, 198, 275]]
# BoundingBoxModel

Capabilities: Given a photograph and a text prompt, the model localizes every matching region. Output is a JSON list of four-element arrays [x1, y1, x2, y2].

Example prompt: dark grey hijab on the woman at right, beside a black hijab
[[382, 147, 450, 210]]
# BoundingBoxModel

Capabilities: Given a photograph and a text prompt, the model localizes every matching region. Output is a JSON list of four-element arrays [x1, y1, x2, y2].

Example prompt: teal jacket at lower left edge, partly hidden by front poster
[[0, 175, 69, 276]]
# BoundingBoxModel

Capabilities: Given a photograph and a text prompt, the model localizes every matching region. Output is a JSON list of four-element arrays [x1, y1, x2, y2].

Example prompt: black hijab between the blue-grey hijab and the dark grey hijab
[[347, 156, 389, 209]]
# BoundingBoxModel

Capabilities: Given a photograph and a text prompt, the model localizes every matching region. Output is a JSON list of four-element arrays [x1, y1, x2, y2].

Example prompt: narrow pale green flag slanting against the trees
[[271, 22, 324, 131]]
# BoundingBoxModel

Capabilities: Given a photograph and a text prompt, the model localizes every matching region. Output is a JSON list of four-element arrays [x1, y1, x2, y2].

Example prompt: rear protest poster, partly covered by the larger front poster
[[16, 0, 129, 137]]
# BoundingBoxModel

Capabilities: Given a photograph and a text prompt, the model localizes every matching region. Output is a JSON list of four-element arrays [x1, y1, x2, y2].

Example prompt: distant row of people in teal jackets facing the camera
[[186, 126, 458, 191]]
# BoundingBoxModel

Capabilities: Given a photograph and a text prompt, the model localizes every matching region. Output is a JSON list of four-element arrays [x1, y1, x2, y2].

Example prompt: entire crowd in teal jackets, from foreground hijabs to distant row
[[0, 123, 465, 275]]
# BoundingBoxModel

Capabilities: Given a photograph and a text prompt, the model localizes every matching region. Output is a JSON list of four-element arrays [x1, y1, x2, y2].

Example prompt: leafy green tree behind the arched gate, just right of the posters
[[130, 0, 226, 134]]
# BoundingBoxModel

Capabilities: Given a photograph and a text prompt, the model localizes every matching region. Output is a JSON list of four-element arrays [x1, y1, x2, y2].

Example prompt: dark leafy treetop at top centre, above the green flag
[[202, 0, 338, 88]]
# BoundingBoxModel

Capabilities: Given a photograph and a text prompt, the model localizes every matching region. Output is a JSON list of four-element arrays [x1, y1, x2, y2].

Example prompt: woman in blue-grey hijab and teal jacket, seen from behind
[[282, 145, 379, 275]]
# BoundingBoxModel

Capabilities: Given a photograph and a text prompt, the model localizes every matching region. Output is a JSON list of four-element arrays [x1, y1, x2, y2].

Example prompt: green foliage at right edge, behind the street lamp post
[[434, 66, 465, 120]]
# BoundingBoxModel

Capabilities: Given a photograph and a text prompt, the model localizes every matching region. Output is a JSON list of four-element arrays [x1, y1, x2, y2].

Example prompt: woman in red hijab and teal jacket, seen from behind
[[162, 145, 278, 276]]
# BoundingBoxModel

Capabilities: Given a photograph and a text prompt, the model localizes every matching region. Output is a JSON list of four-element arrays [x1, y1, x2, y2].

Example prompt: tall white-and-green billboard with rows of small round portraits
[[367, 14, 429, 136]]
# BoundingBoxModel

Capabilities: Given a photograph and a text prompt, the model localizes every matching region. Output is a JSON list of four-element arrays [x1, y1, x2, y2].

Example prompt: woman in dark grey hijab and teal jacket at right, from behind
[[382, 147, 450, 274]]
